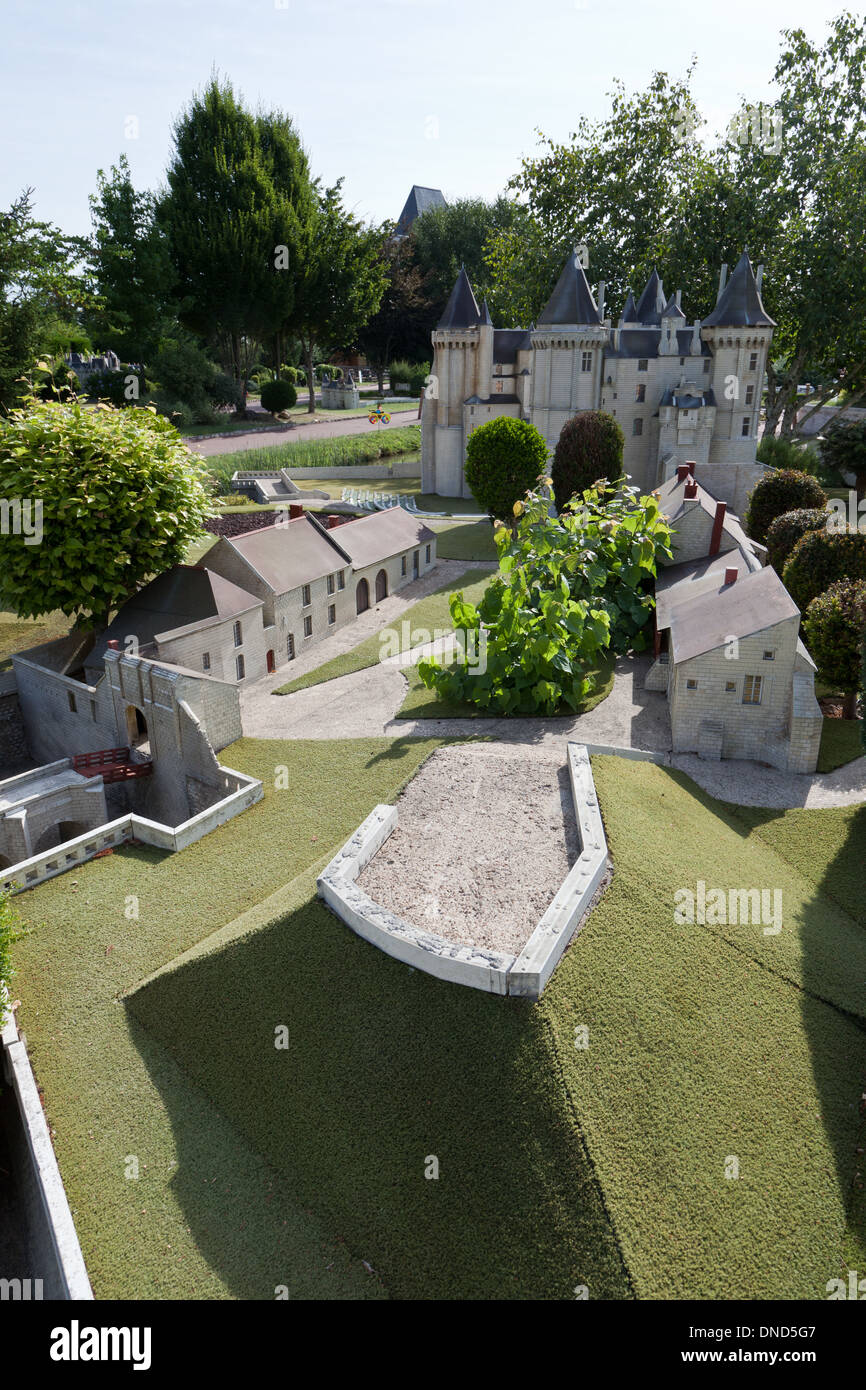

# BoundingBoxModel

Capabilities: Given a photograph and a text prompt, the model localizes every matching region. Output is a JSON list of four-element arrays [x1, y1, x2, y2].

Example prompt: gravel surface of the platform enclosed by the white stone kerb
[[359, 744, 578, 955]]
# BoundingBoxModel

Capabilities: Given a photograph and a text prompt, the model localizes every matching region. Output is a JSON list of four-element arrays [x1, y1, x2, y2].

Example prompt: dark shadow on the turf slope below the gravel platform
[[126, 898, 630, 1300]]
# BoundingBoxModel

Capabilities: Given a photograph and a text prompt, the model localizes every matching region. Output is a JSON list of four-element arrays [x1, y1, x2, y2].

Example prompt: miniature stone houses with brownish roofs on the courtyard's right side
[[645, 460, 823, 773]]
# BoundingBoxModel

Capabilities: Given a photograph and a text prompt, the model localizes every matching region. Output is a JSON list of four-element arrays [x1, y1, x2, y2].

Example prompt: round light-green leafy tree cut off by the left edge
[[0, 400, 210, 626]]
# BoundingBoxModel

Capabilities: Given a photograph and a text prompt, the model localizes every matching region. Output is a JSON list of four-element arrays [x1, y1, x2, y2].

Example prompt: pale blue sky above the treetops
[[0, 0, 858, 232]]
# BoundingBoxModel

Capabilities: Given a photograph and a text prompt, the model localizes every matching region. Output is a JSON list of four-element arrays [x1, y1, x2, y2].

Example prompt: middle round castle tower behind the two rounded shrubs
[[530, 252, 609, 448]]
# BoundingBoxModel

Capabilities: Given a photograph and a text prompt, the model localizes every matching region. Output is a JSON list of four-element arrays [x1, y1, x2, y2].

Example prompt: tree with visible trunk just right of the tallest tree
[[282, 179, 388, 414]]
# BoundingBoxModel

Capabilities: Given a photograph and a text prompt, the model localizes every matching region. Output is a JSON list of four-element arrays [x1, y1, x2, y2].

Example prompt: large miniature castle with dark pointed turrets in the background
[[421, 252, 776, 512]]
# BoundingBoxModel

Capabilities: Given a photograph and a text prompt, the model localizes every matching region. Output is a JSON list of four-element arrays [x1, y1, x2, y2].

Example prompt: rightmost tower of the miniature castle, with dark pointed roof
[[701, 249, 776, 463]]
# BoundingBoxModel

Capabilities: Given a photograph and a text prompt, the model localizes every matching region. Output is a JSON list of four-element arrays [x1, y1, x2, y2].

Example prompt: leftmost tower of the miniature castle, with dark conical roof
[[421, 267, 493, 498]]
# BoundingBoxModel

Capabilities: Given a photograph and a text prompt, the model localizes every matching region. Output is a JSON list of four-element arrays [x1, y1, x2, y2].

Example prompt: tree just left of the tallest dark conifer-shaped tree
[[88, 154, 174, 363]]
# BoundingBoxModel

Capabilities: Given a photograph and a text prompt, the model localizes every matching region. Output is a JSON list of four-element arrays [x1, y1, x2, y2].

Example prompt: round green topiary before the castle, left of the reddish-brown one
[[466, 416, 548, 521]]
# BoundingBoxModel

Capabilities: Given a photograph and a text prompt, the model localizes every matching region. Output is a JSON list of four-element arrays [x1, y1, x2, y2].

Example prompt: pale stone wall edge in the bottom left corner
[[0, 999, 93, 1300]]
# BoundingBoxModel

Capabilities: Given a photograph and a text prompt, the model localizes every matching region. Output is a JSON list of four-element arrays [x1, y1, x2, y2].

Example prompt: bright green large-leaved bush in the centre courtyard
[[418, 488, 671, 714]]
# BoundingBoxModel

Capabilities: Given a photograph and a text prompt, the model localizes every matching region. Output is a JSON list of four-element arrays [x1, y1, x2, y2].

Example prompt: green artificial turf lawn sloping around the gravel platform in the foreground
[[17, 741, 866, 1300]]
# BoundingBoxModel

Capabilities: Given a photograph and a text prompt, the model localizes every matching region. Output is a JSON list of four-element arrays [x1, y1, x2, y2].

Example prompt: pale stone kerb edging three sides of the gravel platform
[[317, 744, 607, 999]]
